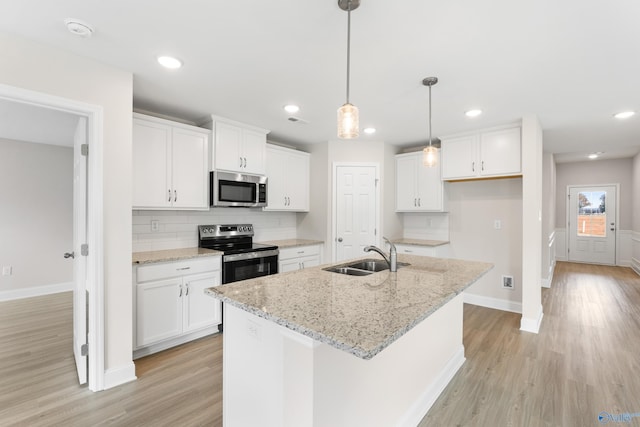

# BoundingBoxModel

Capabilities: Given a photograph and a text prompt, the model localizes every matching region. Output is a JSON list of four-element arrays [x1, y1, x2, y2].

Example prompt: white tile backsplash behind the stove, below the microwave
[[133, 208, 297, 252]]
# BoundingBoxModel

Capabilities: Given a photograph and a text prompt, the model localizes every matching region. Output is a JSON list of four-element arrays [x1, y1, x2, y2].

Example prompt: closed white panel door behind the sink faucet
[[334, 166, 378, 262]]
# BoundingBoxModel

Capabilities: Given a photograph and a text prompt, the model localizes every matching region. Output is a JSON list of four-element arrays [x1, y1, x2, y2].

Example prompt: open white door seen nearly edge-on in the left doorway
[[73, 117, 87, 384]]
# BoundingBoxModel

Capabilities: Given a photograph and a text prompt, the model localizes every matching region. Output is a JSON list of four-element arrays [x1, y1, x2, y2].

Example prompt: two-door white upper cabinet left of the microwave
[[132, 113, 210, 210]]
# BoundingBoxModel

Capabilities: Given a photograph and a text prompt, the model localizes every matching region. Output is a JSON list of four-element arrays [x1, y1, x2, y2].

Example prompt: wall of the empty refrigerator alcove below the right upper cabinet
[[449, 178, 522, 312]]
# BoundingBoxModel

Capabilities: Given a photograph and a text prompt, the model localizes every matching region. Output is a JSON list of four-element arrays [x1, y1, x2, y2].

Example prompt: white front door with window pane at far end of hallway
[[567, 185, 617, 265]]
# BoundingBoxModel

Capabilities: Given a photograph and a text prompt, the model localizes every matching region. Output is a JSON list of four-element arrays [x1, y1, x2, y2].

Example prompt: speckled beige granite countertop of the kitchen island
[[206, 255, 493, 359]]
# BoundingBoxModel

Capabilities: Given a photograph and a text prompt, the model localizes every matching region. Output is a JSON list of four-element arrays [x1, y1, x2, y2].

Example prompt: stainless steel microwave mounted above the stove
[[209, 171, 267, 208]]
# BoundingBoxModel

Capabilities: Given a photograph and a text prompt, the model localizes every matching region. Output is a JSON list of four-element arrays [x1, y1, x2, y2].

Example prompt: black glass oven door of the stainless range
[[222, 249, 278, 284]]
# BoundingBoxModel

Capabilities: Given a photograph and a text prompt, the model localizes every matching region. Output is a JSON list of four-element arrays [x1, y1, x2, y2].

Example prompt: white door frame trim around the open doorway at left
[[0, 84, 105, 391]]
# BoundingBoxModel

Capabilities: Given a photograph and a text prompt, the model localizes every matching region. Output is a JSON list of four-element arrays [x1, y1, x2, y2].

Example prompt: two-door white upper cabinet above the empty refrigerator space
[[441, 126, 522, 180]]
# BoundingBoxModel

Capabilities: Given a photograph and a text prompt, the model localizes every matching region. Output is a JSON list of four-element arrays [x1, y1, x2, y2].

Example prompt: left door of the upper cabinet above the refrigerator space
[[440, 135, 481, 179]]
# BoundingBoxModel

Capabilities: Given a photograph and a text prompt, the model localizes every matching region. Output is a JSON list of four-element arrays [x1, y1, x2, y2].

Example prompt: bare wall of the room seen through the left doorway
[[0, 139, 73, 300]]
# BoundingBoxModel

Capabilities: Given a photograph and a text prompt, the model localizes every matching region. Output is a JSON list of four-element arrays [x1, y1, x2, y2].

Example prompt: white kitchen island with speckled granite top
[[207, 255, 492, 427]]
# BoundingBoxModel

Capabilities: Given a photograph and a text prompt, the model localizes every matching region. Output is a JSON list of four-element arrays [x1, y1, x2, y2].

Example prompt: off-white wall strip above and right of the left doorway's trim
[[0, 33, 133, 382]]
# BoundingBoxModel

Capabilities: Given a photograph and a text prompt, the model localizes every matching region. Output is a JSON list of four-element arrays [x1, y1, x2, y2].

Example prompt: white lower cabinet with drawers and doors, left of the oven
[[133, 257, 222, 358]]
